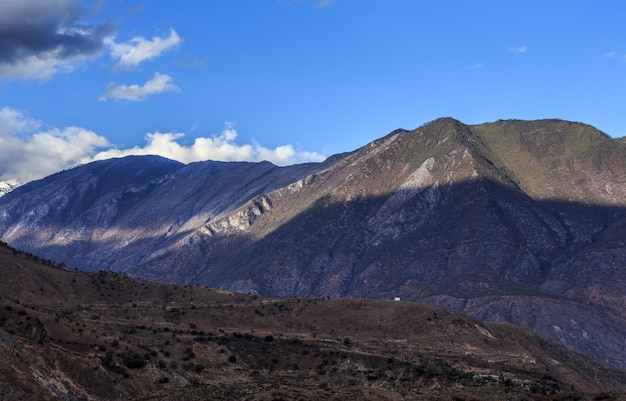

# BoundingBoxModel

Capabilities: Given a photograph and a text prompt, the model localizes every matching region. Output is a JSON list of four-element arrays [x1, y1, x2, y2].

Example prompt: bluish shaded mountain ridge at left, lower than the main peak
[[0, 156, 336, 271]]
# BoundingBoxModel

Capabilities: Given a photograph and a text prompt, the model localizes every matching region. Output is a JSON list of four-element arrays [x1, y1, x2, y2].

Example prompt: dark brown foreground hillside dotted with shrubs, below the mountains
[[0, 244, 626, 401]]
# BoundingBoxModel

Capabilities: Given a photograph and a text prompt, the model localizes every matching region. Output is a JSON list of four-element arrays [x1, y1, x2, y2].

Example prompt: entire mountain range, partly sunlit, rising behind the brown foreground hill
[[0, 118, 626, 369]]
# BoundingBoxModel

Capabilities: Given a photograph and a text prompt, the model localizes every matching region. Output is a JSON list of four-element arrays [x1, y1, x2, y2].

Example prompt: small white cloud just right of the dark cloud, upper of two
[[106, 29, 182, 69]]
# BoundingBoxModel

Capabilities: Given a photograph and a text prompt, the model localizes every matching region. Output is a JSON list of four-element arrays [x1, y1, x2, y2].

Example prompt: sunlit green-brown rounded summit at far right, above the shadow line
[[470, 119, 626, 205]]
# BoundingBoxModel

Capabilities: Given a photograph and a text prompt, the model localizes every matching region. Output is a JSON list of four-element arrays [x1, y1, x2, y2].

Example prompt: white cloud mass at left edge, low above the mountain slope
[[0, 107, 110, 183]]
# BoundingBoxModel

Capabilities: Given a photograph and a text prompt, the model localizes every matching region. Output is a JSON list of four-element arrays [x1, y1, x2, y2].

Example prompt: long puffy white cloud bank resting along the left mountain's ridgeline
[[94, 124, 325, 165]]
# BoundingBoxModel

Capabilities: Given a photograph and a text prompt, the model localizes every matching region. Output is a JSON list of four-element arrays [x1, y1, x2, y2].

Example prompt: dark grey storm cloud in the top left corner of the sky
[[0, 0, 113, 76]]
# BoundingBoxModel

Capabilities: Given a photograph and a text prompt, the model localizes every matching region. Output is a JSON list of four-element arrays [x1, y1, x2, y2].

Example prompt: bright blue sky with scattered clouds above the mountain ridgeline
[[0, 0, 626, 182]]
